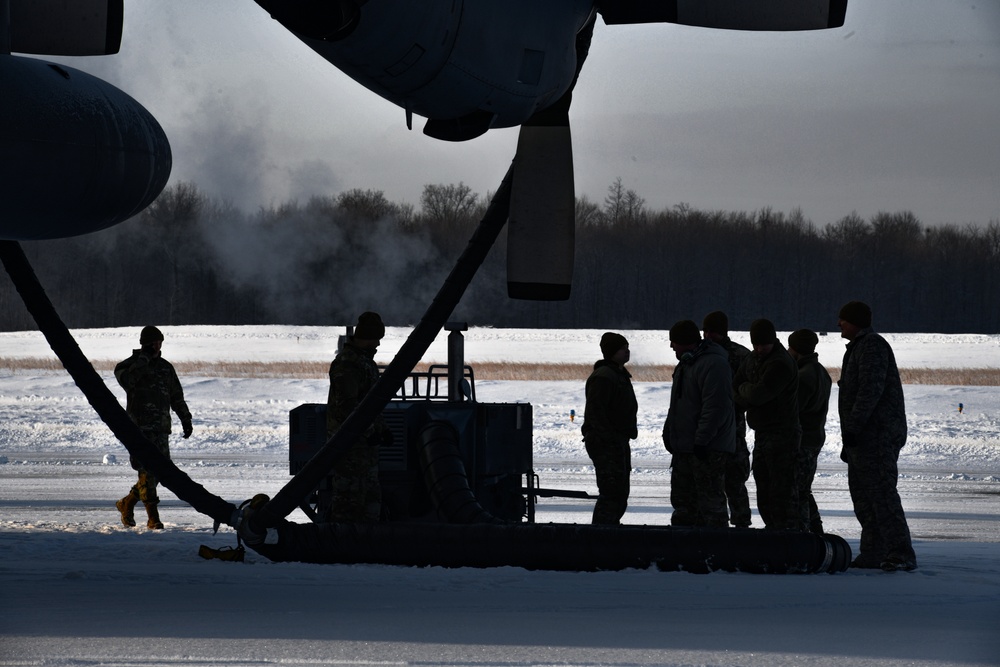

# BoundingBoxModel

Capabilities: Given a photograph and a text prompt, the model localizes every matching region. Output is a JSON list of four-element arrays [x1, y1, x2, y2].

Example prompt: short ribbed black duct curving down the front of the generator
[[420, 420, 505, 524]]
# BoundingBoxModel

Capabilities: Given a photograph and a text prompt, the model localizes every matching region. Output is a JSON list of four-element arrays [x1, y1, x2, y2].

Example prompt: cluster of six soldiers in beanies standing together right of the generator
[[582, 301, 916, 571]]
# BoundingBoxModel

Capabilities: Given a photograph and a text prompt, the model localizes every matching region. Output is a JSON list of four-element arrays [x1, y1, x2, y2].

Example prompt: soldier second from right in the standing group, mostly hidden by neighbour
[[788, 329, 833, 535]]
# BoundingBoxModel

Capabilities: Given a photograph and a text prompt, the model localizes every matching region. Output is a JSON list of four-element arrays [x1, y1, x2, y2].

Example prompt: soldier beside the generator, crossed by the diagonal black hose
[[326, 312, 392, 523]]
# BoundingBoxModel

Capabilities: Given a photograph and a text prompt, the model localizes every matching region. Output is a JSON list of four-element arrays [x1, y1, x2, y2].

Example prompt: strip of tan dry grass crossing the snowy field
[[0, 357, 1000, 387]]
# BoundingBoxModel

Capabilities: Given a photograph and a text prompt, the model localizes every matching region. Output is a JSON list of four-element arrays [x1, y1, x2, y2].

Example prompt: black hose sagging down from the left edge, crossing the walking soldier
[[0, 241, 236, 526]]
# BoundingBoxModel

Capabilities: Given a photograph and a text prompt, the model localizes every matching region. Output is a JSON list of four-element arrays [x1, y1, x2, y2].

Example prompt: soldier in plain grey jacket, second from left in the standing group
[[663, 320, 736, 528]]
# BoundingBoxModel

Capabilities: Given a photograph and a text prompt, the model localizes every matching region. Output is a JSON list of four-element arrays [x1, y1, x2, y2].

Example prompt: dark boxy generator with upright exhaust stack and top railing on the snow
[[288, 324, 535, 523]]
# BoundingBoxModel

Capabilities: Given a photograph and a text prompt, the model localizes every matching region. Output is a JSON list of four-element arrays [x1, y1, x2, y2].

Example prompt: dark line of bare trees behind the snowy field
[[0, 179, 1000, 333]]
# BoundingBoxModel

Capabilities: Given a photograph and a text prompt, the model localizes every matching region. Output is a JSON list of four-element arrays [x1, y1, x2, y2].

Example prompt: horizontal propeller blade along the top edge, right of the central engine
[[598, 0, 847, 31]]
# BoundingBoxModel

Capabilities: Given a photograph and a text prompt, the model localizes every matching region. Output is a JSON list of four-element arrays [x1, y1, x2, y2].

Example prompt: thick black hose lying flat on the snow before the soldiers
[[242, 521, 851, 574]]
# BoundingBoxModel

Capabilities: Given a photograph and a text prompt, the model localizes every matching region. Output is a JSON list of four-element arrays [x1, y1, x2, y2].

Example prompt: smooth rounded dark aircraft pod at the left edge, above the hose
[[0, 55, 171, 240]]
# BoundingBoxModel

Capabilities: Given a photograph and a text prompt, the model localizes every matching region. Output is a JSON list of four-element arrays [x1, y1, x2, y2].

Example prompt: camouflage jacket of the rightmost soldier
[[837, 327, 906, 437]]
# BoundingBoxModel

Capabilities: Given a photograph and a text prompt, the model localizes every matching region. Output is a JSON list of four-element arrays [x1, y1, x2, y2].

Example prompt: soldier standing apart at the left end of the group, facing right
[[580, 331, 639, 525]]
